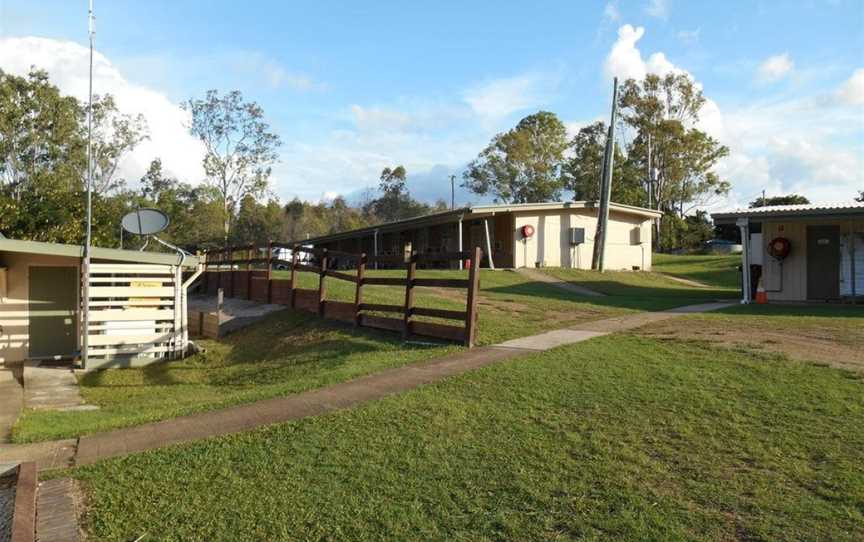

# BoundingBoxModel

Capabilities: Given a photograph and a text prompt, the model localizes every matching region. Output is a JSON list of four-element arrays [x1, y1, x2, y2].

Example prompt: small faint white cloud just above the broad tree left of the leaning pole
[[463, 75, 548, 120]]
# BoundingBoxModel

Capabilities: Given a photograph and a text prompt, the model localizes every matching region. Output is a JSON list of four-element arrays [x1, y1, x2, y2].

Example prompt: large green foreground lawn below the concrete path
[[64, 334, 864, 540]]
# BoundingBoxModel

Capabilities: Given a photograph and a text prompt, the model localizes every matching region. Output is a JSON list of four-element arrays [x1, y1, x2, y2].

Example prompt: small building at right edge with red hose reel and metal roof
[[711, 203, 864, 303]]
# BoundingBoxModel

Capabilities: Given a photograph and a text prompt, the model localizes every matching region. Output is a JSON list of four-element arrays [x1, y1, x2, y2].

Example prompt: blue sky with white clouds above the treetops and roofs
[[0, 0, 864, 210]]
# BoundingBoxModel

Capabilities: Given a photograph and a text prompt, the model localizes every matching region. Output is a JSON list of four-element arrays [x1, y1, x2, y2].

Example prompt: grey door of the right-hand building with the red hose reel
[[807, 226, 840, 300]]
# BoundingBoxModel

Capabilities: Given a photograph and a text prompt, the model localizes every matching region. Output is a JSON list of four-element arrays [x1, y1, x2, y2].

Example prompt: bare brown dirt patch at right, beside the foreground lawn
[[635, 318, 864, 372]]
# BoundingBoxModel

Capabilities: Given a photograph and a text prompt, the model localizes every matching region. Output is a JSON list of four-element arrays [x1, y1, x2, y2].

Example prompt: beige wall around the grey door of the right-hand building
[[761, 219, 864, 301]]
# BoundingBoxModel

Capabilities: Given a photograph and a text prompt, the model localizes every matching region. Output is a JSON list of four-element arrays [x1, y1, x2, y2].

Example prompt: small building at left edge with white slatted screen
[[0, 238, 200, 369]]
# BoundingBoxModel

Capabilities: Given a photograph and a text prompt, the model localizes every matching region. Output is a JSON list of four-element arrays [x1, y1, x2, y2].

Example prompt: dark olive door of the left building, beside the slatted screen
[[29, 267, 78, 358]]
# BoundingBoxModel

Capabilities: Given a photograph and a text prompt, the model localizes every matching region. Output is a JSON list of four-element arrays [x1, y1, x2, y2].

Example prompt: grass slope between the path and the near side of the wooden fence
[[13, 310, 456, 442]]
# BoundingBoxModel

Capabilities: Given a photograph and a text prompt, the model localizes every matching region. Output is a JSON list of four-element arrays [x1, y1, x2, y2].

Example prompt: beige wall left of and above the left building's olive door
[[0, 252, 78, 364]]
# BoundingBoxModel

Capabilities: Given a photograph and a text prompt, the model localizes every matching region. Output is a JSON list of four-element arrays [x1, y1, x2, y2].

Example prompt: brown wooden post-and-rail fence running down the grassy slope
[[203, 243, 483, 348]]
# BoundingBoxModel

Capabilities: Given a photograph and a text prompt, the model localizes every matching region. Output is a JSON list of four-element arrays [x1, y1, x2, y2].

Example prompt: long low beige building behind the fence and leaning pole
[[303, 201, 661, 270]]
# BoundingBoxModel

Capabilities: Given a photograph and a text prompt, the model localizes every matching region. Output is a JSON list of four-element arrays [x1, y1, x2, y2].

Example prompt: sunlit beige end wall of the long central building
[[513, 209, 651, 271]]
